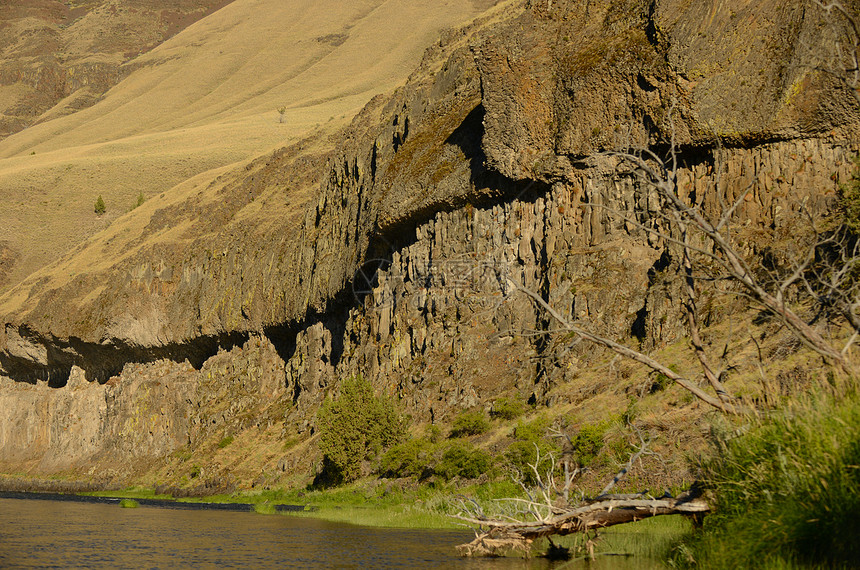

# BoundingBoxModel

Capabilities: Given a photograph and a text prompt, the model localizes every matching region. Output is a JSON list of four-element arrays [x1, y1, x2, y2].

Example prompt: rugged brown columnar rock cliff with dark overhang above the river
[[0, 0, 860, 486]]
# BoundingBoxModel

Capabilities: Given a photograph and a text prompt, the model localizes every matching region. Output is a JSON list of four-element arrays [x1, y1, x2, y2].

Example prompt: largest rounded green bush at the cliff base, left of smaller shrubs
[[315, 377, 406, 485]]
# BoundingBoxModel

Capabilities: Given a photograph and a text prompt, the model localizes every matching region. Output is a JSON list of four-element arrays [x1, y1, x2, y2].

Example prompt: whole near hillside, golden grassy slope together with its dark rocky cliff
[[0, 0, 860, 506]]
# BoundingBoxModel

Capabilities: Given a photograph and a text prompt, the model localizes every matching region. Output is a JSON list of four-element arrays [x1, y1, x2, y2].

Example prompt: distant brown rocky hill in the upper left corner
[[0, 0, 235, 139]]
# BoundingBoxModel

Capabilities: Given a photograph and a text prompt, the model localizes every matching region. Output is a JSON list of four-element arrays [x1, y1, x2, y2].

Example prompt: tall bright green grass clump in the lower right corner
[[679, 392, 860, 568]]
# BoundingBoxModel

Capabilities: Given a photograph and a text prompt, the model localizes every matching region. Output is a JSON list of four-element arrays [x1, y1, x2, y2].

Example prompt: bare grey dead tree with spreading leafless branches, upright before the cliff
[[507, 123, 860, 413]]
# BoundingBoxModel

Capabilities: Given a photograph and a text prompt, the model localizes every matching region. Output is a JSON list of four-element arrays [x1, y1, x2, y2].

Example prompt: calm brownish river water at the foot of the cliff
[[0, 499, 546, 570]]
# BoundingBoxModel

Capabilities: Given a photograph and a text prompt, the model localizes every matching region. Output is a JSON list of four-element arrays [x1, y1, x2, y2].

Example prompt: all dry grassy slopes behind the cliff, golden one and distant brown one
[[0, 0, 490, 292]]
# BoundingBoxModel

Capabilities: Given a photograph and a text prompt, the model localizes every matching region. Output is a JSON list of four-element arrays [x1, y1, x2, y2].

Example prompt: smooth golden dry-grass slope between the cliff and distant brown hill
[[0, 0, 494, 292]]
